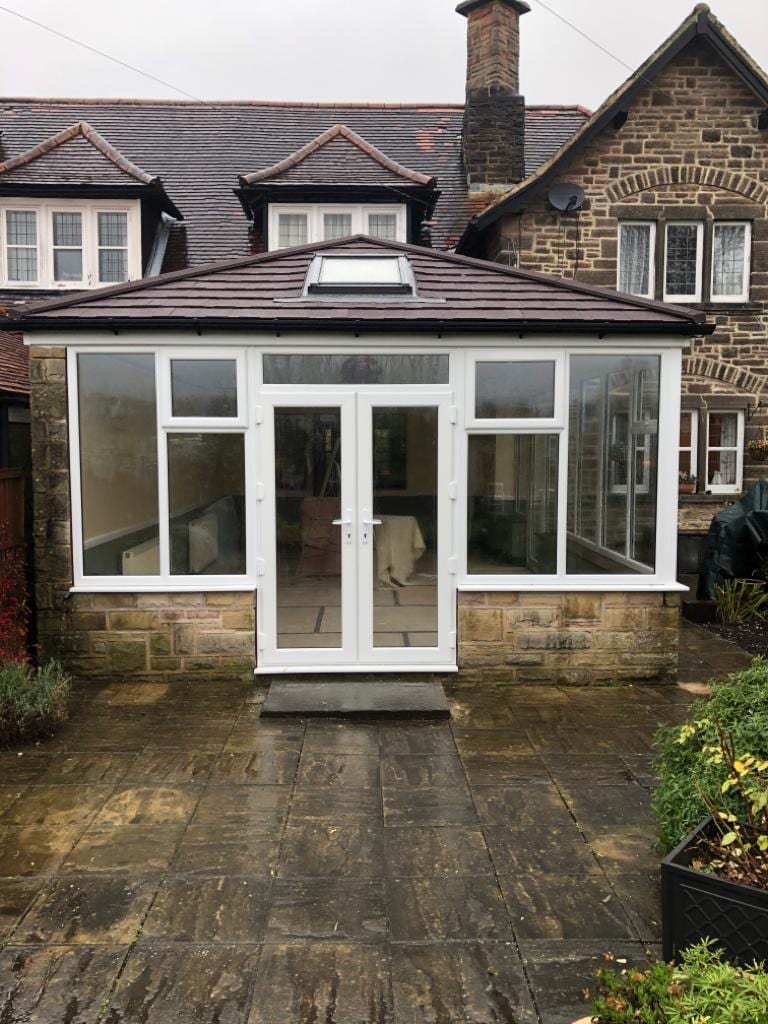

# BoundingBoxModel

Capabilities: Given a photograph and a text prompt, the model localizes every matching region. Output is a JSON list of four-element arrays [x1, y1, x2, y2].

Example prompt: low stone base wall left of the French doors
[[47, 592, 256, 682]]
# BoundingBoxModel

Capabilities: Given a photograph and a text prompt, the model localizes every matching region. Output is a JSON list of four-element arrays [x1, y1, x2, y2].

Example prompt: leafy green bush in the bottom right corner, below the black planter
[[592, 940, 768, 1024]]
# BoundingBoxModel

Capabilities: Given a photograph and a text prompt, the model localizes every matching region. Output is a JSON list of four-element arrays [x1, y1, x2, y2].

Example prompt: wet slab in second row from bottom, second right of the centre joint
[[499, 873, 637, 939]]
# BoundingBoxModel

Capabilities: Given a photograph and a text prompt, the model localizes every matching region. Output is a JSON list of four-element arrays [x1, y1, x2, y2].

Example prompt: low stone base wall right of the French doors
[[458, 592, 680, 686]]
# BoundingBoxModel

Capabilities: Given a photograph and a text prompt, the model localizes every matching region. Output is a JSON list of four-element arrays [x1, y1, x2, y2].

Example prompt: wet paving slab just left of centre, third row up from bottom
[[278, 821, 384, 879]]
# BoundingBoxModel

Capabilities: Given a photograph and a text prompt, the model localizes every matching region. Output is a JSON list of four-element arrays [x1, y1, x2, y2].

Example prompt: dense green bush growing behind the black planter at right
[[653, 657, 768, 854]]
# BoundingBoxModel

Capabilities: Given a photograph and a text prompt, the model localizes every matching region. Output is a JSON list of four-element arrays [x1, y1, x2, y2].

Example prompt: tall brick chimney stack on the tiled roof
[[456, 0, 530, 191]]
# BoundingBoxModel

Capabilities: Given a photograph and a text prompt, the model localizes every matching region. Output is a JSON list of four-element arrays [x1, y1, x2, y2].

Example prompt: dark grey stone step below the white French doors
[[261, 681, 451, 719]]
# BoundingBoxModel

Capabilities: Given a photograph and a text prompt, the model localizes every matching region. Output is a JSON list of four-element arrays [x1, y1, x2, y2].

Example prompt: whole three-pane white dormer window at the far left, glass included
[[0, 200, 141, 289]]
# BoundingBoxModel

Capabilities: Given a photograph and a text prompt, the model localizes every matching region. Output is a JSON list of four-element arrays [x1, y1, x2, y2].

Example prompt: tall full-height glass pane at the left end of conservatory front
[[78, 353, 160, 577]]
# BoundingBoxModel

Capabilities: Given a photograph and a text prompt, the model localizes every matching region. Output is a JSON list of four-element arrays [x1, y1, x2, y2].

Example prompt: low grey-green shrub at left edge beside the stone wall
[[0, 662, 72, 746]]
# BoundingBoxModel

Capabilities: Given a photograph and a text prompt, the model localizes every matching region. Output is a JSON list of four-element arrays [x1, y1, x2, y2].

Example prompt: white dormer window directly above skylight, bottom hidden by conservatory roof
[[268, 203, 408, 250]]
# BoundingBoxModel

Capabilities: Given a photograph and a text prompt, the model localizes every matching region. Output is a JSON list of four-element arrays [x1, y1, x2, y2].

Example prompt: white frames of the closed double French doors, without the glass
[[256, 386, 457, 675]]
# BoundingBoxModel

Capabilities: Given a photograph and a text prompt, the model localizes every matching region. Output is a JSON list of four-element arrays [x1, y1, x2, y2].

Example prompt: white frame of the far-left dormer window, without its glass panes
[[0, 199, 141, 292]]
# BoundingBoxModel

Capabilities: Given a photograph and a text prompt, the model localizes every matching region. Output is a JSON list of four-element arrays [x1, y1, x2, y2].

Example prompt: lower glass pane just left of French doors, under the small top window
[[168, 433, 246, 575]]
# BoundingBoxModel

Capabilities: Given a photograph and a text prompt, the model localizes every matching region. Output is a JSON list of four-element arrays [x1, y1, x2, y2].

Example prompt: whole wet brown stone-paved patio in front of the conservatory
[[0, 671, 712, 1024]]
